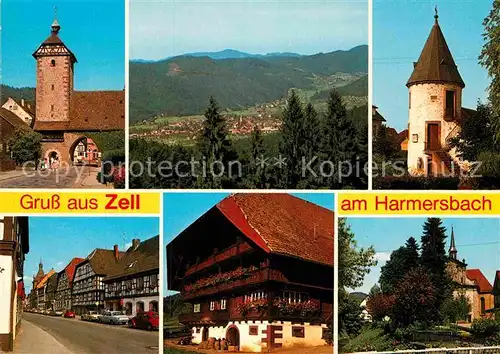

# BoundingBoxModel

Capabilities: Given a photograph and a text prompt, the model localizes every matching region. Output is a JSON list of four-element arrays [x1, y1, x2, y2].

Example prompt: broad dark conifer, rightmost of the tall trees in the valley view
[[322, 90, 358, 189]]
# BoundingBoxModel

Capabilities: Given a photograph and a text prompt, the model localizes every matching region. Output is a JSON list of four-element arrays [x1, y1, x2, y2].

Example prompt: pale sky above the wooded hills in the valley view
[[130, 0, 368, 60]]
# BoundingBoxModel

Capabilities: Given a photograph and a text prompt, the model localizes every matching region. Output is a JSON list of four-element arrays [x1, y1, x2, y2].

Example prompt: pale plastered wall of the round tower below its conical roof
[[408, 83, 462, 171]]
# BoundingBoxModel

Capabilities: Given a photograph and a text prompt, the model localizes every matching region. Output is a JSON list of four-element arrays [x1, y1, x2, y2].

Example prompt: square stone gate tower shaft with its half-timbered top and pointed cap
[[33, 20, 77, 122]]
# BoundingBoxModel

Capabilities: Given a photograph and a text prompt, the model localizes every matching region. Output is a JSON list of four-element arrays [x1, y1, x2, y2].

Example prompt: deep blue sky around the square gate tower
[[0, 0, 125, 90]]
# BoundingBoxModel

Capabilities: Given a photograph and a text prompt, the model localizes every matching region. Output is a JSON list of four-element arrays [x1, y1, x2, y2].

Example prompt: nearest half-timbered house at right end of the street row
[[103, 236, 160, 317]]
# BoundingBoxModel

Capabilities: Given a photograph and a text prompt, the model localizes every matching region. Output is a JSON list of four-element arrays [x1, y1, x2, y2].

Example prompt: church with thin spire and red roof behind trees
[[447, 228, 495, 323]]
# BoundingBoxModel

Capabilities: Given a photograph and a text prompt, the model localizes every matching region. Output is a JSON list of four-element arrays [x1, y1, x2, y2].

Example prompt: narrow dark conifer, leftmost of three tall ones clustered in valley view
[[279, 90, 304, 188]]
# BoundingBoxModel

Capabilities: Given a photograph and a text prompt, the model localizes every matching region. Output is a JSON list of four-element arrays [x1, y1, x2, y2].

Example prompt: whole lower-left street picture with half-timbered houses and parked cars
[[0, 216, 160, 354]]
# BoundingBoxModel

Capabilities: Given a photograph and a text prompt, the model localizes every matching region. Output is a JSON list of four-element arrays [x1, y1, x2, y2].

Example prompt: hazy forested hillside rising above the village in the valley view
[[130, 45, 368, 123]]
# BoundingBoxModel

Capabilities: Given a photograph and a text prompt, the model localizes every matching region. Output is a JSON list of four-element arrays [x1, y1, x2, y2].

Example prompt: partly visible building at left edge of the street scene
[[0, 215, 29, 352]]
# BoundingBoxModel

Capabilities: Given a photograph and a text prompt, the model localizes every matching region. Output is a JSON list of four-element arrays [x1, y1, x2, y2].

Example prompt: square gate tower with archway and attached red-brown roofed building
[[33, 20, 125, 165]]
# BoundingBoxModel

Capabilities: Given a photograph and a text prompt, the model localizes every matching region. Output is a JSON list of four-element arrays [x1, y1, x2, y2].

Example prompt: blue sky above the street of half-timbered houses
[[24, 216, 160, 292]]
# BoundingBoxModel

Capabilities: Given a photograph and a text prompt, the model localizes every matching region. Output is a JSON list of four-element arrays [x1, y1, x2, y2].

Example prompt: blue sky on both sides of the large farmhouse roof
[[163, 193, 335, 291]]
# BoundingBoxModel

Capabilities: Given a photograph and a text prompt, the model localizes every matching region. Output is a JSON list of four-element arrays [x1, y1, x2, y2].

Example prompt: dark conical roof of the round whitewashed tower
[[406, 8, 465, 87]]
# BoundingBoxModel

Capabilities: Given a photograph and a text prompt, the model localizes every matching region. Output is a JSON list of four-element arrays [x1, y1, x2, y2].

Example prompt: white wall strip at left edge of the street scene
[[0, 256, 14, 334]]
